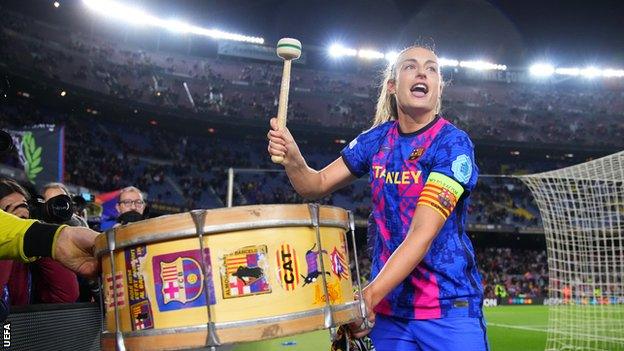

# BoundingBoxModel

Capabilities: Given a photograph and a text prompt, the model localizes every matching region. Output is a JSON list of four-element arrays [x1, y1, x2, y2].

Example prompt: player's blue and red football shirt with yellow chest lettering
[[342, 116, 483, 319]]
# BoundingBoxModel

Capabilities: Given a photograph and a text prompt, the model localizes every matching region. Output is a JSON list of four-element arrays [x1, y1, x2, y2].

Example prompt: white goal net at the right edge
[[519, 151, 624, 350]]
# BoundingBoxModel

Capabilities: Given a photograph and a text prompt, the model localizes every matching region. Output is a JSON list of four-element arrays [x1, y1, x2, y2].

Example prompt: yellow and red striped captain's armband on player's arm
[[417, 172, 464, 220]]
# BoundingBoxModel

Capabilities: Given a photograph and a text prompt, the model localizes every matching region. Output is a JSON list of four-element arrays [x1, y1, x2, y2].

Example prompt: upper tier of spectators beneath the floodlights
[[0, 11, 624, 147]]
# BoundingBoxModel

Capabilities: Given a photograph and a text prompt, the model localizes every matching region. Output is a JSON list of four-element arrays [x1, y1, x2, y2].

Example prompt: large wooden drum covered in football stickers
[[96, 204, 361, 350]]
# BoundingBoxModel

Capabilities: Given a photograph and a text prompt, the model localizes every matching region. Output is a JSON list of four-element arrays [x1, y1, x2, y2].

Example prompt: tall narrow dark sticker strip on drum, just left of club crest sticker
[[125, 245, 154, 330]]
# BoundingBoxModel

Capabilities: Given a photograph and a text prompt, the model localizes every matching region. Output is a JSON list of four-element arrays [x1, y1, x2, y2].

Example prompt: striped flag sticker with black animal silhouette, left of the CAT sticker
[[221, 245, 271, 299]]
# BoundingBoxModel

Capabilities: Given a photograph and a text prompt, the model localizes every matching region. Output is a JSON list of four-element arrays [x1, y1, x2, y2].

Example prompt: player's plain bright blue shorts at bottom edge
[[369, 314, 490, 351]]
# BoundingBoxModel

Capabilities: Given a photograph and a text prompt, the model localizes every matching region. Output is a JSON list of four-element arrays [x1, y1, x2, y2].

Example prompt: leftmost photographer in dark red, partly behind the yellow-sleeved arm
[[0, 179, 78, 306]]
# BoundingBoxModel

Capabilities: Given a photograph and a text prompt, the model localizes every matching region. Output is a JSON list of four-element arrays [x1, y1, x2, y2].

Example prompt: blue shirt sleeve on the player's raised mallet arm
[[340, 126, 383, 178]]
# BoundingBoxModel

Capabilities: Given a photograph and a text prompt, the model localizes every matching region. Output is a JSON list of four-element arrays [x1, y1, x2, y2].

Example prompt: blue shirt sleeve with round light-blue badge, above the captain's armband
[[431, 129, 479, 195]]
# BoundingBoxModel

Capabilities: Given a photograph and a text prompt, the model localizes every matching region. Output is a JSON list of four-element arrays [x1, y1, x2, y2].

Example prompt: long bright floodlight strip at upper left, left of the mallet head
[[82, 0, 264, 44]]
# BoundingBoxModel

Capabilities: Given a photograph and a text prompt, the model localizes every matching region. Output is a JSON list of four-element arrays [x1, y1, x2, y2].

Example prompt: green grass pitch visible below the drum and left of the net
[[233, 306, 548, 351]]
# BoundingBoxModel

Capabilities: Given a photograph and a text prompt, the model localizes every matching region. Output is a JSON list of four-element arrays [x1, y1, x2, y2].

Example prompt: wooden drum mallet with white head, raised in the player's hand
[[271, 38, 301, 163]]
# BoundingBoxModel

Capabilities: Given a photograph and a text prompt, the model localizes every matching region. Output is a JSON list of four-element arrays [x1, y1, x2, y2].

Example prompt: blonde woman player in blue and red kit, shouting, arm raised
[[268, 46, 489, 351]]
